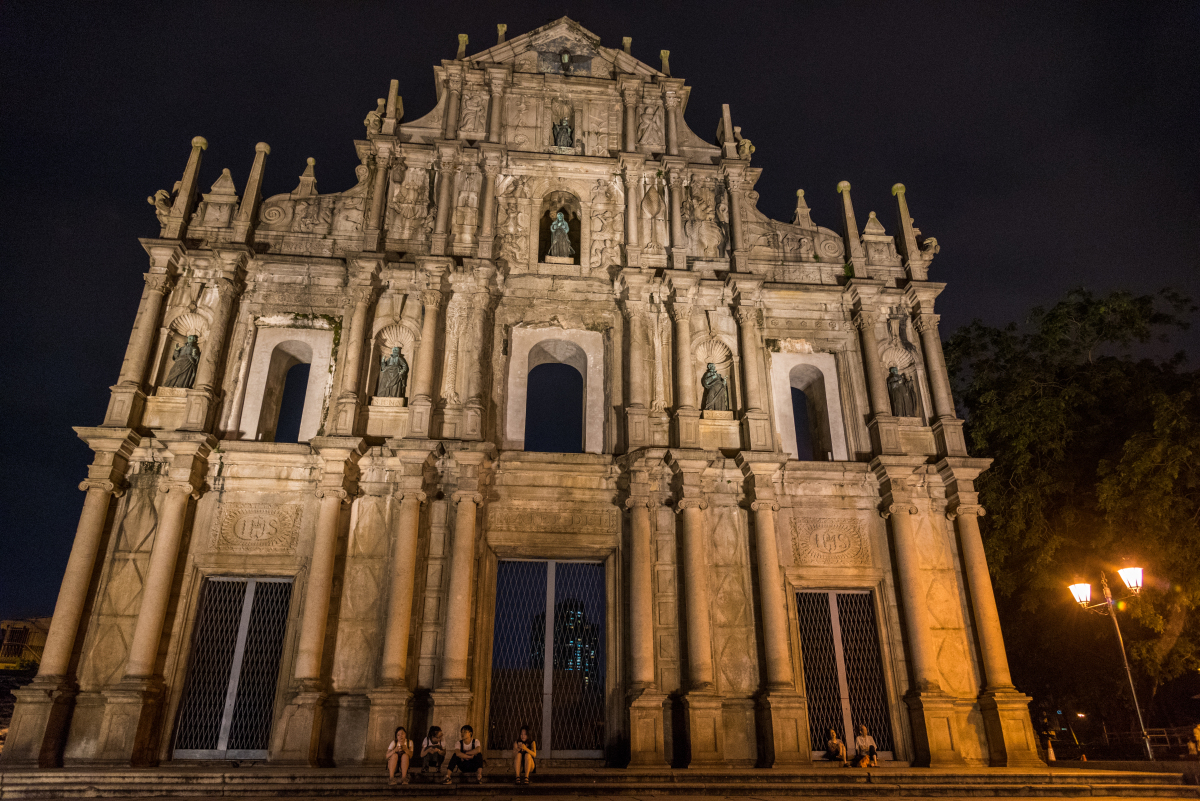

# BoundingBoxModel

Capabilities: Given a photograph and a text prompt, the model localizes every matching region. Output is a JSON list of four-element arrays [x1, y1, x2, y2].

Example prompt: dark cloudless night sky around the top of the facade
[[0, 0, 1200, 618]]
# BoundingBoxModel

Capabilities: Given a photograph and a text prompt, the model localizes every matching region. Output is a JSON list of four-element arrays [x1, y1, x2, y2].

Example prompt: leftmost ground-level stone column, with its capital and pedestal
[[0, 428, 142, 767]]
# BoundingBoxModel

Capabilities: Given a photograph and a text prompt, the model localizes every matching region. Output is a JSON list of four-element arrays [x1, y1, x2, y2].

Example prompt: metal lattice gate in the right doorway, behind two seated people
[[796, 590, 894, 759]]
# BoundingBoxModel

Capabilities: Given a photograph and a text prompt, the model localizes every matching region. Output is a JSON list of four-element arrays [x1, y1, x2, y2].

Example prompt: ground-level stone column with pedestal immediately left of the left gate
[[97, 432, 216, 765]]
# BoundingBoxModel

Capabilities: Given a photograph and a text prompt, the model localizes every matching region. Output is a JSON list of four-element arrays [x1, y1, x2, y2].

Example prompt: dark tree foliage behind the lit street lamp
[[946, 289, 1200, 728]]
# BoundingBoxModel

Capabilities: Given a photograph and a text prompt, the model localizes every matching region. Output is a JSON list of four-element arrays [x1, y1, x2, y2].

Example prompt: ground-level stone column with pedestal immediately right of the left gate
[[271, 436, 362, 767]]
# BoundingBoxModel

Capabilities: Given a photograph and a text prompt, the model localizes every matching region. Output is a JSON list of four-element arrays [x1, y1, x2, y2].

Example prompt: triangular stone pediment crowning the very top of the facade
[[470, 17, 662, 78]]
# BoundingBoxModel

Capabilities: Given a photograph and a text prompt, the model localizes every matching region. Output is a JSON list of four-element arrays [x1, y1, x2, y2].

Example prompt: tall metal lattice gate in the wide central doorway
[[487, 560, 607, 758]]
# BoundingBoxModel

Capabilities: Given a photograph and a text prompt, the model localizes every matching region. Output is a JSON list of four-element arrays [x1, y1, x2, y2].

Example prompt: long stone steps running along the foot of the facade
[[0, 764, 1200, 801]]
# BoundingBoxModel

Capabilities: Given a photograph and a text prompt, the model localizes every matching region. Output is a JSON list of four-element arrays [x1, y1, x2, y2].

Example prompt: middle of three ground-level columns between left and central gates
[[367, 489, 425, 753]]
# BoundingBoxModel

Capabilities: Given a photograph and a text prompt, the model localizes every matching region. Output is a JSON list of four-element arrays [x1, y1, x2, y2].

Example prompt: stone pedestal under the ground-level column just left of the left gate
[[88, 679, 163, 767]]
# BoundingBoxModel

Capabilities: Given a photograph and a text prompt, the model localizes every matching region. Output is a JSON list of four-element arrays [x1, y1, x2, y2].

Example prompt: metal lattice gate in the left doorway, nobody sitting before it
[[174, 578, 292, 759]]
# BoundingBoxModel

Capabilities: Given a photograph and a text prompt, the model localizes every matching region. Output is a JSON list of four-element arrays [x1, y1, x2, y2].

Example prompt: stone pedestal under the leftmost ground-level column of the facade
[[0, 679, 78, 767]]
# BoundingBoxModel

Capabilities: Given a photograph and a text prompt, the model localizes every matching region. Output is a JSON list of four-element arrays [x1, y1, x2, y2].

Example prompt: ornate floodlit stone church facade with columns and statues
[[2, 18, 1037, 766]]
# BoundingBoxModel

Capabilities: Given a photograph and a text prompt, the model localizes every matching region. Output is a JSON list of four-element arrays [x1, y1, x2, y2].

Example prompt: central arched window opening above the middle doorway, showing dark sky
[[524, 362, 583, 453]]
